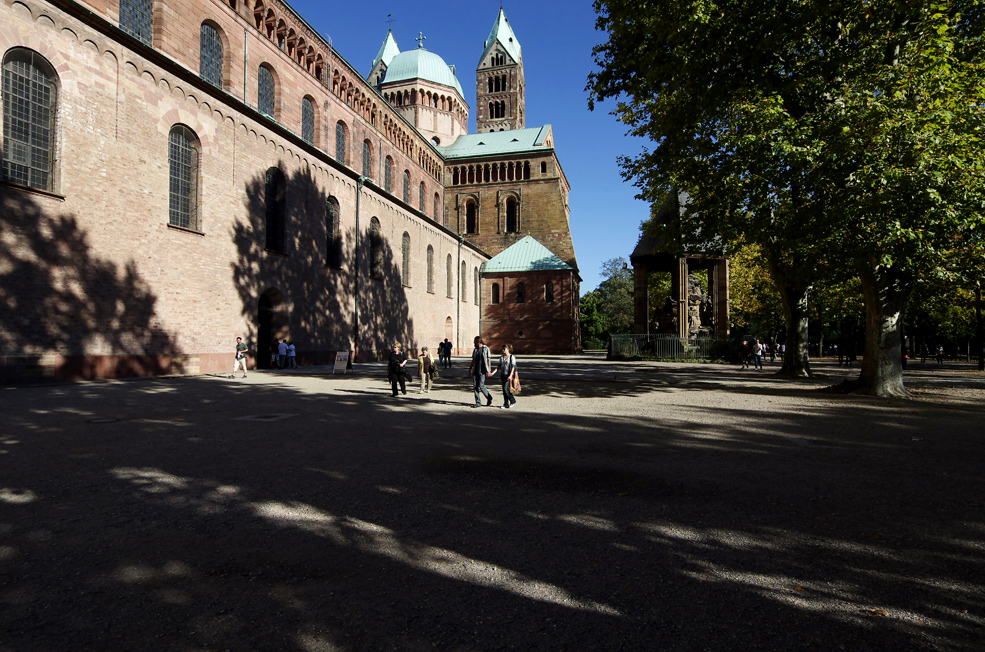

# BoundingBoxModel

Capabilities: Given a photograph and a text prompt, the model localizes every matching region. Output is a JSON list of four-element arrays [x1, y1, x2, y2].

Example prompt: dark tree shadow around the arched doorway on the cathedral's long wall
[[232, 171, 413, 364]]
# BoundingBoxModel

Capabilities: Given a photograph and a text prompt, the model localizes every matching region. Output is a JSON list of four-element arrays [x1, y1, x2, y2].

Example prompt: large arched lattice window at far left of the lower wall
[[2, 48, 58, 190]]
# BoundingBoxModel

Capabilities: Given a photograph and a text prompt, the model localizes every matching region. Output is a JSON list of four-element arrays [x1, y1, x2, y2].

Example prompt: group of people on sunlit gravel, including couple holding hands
[[387, 337, 519, 410]]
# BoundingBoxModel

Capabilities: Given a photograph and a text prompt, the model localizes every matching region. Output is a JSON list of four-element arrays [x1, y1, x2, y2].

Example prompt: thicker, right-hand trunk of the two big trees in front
[[856, 260, 910, 398]]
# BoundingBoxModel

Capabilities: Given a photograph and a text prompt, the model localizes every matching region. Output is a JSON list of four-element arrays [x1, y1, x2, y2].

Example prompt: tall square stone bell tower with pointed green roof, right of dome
[[475, 7, 526, 133]]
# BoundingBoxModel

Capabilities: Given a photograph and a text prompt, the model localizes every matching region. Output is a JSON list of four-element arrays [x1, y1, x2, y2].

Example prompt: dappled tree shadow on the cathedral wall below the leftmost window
[[0, 186, 183, 382]]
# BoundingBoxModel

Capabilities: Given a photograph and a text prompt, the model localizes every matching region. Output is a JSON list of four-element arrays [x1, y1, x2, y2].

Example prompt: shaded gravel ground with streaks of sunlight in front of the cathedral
[[0, 356, 985, 652]]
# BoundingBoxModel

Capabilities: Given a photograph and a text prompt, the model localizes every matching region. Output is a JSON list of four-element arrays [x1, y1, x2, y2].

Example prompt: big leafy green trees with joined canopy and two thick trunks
[[588, 0, 985, 395]]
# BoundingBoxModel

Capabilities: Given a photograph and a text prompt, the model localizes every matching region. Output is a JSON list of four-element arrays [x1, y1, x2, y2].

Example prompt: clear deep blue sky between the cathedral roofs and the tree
[[289, 0, 649, 294]]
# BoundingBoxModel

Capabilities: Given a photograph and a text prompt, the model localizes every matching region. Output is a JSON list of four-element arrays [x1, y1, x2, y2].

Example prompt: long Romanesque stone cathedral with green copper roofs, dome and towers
[[0, 0, 581, 381]]
